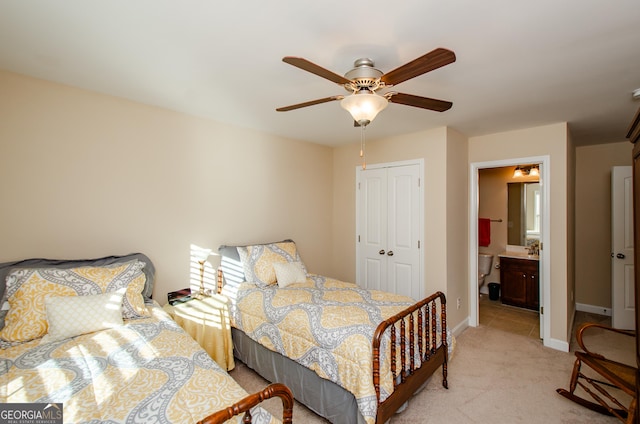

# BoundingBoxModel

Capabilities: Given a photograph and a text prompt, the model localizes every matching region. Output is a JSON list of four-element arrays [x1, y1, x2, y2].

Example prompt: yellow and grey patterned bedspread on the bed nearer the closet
[[231, 275, 450, 423]]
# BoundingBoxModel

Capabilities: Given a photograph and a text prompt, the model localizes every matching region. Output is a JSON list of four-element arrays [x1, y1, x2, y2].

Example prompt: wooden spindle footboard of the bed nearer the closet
[[372, 292, 449, 423]]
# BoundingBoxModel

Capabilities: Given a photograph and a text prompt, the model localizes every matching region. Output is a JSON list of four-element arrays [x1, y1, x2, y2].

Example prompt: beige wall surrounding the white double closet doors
[[333, 127, 468, 327]]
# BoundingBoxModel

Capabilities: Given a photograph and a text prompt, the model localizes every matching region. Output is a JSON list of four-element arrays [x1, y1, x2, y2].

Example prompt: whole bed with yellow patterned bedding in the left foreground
[[0, 256, 293, 423]]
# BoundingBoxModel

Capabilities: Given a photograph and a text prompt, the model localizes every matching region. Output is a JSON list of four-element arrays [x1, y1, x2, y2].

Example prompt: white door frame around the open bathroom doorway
[[469, 155, 552, 346]]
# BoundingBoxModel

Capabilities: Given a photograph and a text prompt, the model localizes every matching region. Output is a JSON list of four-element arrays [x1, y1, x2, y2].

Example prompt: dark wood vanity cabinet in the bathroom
[[500, 257, 540, 311]]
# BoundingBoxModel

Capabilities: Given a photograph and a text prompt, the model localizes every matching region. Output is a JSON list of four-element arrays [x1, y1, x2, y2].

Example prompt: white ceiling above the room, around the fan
[[0, 0, 640, 146]]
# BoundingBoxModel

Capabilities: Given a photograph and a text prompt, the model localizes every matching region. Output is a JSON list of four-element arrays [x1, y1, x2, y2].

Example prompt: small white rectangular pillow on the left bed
[[40, 287, 127, 343]]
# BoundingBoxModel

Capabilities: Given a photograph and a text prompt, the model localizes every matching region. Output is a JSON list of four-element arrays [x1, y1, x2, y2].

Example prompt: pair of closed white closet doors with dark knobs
[[356, 164, 423, 300]]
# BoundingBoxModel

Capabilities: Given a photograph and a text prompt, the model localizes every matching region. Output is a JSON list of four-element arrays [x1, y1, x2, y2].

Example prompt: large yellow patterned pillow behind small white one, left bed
[[0, 260, 149, 342]]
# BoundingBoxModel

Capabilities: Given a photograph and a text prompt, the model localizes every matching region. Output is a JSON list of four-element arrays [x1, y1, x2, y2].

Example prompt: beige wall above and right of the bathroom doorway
[[469, 123, 573, 342]]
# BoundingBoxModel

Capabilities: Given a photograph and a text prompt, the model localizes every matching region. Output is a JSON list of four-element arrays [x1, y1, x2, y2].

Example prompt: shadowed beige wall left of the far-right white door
[[575, 141, 633, 308]]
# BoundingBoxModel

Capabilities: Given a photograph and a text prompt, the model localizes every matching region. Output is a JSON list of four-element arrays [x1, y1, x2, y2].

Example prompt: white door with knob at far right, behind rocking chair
[[611, 166, 635, 330]]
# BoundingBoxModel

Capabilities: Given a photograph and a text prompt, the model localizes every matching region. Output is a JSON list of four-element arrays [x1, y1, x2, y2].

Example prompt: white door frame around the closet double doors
[[355, 158, 426, 300]]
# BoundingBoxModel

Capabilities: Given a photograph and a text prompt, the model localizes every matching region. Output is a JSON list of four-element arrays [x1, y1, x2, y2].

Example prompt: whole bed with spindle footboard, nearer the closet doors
[[219, 240, 452, 423]]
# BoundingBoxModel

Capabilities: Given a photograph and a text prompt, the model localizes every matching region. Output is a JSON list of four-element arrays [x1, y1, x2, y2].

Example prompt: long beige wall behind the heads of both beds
[[0, 72, 333, 303]]
